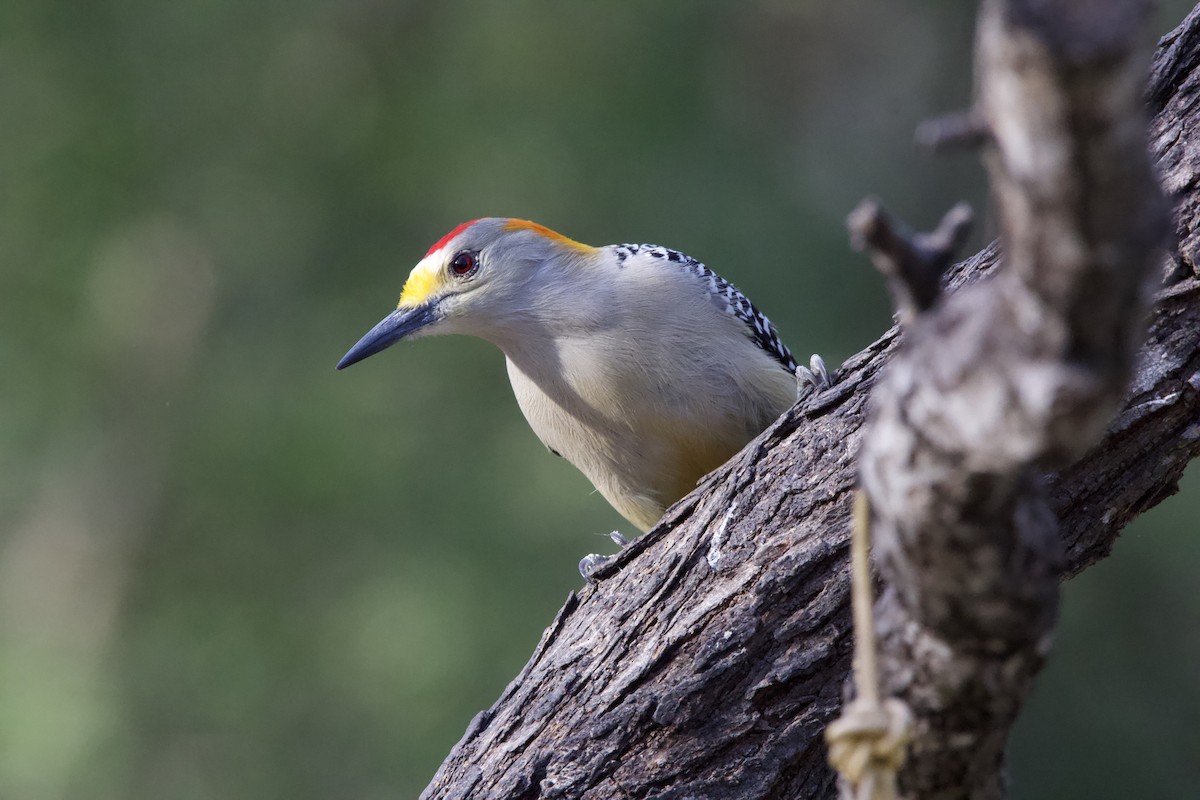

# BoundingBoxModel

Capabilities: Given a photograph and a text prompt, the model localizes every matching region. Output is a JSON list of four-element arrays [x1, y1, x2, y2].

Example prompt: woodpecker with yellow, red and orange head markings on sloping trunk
[[337, 217, 828, 542]]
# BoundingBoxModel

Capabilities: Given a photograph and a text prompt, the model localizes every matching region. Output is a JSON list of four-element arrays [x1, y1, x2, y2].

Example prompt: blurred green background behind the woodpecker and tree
[[0, 0, 1200, 800]]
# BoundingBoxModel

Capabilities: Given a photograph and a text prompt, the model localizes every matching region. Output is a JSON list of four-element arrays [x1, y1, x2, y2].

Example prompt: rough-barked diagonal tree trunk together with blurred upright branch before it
[[422, 0, 1200, 800]]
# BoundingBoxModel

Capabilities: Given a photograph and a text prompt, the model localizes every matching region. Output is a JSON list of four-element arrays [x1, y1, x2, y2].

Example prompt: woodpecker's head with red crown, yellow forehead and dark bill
[[337, 217, 596, 369]]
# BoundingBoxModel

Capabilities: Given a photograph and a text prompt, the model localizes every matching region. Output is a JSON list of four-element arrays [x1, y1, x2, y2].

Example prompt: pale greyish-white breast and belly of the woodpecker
[[502, 250, 796, 530]]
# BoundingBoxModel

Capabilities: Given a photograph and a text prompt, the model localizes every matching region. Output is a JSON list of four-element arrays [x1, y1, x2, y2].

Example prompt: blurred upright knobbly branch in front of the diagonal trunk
[[860, 0, 1166, 798]]
